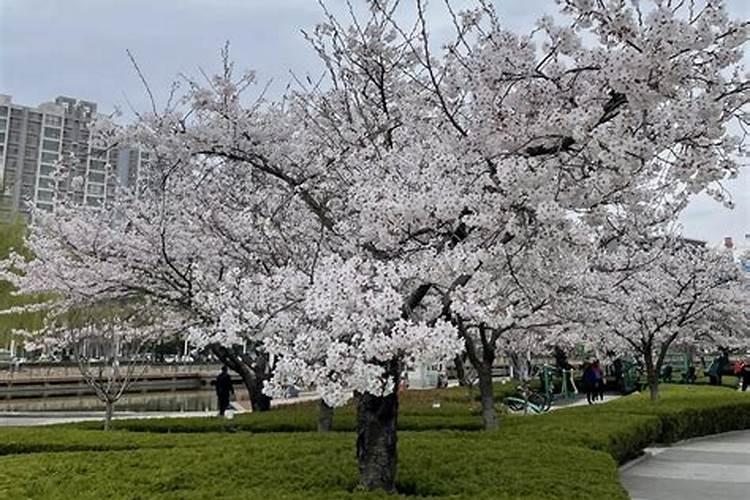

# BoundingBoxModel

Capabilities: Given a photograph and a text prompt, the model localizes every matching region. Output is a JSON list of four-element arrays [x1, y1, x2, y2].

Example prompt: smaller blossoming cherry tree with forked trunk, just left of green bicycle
[[444, 223, 591, 429]]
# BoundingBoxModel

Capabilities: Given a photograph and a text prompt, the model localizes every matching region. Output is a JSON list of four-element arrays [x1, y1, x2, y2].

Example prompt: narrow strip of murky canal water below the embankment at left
[[0, 390, 222, 412]]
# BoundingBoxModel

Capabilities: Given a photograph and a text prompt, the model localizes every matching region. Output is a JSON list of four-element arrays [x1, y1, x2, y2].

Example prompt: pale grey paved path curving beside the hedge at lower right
[[620, 431, 750, 500]]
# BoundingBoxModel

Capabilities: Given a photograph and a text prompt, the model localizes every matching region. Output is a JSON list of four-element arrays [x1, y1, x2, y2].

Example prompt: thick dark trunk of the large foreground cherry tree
[[357, 370, 400, 492]]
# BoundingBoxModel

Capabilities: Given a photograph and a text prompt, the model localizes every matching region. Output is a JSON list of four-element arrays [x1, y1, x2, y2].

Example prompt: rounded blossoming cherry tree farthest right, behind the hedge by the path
[[588, 235, 750, 401]]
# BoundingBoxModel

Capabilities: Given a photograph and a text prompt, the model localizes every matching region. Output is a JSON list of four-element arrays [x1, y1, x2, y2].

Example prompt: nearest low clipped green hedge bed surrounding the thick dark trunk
[[0, 432, 627, 500]]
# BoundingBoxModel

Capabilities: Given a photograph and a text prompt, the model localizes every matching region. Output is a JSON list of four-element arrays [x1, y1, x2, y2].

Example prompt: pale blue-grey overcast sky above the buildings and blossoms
[[0, 0, 750, 243]]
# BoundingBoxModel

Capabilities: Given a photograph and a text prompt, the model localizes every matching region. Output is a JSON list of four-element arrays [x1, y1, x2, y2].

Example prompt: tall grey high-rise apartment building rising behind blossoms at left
[[0, 94, 148, 219]]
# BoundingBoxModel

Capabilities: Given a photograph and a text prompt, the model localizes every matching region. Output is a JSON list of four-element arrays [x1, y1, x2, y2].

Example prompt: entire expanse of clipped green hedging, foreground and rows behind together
[[0, 386, 750, 500]]
